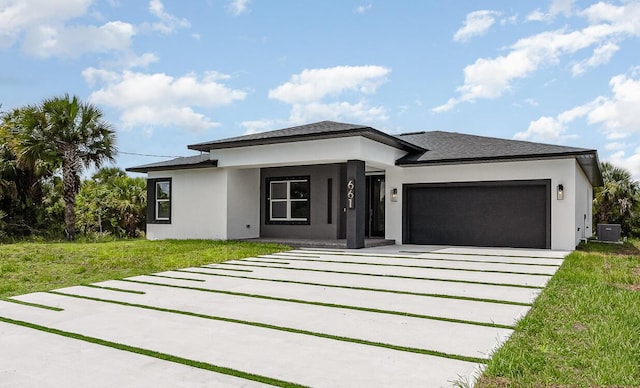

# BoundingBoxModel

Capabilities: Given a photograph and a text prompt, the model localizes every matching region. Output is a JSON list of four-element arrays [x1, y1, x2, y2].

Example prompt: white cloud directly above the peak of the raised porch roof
[[269, 65, 391, 124]]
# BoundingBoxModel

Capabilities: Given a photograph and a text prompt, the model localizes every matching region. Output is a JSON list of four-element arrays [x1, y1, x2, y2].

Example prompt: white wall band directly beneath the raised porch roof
[[211, 136, 405, 167]]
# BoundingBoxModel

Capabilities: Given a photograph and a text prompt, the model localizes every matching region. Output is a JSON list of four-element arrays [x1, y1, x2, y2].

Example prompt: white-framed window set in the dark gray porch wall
[[267, 177, 309, 224]]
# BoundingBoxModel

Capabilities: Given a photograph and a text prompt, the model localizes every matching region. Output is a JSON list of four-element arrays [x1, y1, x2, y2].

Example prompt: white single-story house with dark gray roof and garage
[[128, 121, 602, 250]]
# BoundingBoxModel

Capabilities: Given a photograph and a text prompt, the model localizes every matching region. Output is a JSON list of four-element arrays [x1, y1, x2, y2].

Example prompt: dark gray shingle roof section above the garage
[[396, 131, 602, 186]]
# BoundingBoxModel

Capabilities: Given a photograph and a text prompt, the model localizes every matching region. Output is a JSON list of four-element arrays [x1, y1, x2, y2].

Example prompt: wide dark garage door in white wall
[[403, 180, 551, 249]]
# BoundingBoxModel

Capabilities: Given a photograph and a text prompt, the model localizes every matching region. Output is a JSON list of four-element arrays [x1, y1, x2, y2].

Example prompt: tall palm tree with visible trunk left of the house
[[18, 94, 117, 240]]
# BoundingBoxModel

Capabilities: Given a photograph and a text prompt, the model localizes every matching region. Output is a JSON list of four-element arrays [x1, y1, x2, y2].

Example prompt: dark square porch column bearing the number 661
[[347, 160, 367, 249]]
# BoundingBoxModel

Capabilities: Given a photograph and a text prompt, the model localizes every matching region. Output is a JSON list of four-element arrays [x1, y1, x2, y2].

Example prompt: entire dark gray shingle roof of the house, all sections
[[127, 121, 602, 186]]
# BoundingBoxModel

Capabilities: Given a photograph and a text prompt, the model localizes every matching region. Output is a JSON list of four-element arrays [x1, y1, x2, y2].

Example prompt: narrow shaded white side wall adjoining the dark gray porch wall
[[227, 168, 261, 239]]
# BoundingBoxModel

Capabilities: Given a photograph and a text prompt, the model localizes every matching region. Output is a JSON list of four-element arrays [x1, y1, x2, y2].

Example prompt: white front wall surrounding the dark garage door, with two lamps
[[385, 158, 576, 250]]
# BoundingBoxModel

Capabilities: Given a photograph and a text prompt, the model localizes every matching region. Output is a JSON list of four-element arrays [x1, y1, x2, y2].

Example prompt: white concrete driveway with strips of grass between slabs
[[0, 245, 568, 387]]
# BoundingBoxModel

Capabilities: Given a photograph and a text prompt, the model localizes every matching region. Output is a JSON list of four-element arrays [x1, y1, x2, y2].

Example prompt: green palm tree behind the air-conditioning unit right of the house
[[593, 162, 639, 235]]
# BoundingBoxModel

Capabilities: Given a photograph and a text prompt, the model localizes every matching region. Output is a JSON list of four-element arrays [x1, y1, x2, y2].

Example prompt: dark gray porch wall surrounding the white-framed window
[[256, 164, 342, 239]]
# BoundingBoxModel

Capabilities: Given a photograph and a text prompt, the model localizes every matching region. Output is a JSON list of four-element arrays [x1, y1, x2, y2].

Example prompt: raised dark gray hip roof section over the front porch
[[188, 121, 424, 152]]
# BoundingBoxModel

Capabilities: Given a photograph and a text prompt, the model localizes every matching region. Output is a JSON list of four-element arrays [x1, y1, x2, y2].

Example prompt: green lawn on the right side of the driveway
[[478, 241, 640, 387]]
